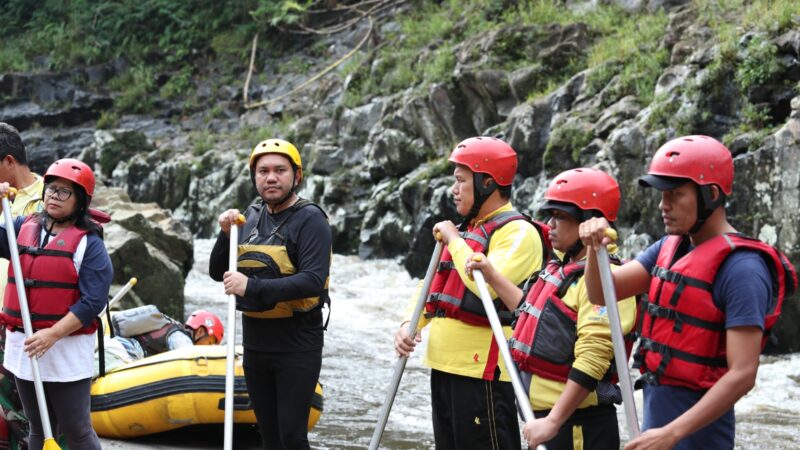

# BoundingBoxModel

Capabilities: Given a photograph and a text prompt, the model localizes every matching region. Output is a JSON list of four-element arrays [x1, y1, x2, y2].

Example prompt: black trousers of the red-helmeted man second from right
[[534, 405, 619, 450]]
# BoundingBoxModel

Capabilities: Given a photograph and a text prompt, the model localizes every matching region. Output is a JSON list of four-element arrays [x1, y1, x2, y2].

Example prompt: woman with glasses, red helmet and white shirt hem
[[0, 159, 113, 450]]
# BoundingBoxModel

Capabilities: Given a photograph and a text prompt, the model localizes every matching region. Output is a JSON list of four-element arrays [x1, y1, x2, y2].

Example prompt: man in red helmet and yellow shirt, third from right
[[395, 137, 546, 450]]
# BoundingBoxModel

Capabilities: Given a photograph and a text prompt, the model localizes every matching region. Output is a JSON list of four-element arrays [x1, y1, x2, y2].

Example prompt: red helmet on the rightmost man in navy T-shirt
[[639, 136, 733, 195]]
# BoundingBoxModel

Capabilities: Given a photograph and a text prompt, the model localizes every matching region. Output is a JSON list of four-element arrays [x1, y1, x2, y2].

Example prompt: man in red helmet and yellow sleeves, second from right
[[466, 169, 636, 450]]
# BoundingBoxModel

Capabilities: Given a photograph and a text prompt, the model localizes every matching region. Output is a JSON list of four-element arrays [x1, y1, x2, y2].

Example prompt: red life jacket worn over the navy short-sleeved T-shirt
[[634, 233, 797, 390]]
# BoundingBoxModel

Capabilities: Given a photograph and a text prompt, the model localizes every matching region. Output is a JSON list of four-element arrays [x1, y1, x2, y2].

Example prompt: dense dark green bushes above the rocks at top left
[[0, 0, 312, 112]]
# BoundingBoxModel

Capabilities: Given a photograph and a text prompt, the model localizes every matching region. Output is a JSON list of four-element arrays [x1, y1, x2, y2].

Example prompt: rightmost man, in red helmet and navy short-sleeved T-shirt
[[580, 136, 797, 450]]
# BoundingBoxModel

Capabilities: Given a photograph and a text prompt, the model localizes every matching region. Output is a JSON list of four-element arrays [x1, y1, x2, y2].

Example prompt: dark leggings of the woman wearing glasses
[[17, 378, 100, 450]]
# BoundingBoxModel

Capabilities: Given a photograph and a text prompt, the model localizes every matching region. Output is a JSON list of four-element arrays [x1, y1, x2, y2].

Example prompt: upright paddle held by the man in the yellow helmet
[[224, 214, 244, 450]]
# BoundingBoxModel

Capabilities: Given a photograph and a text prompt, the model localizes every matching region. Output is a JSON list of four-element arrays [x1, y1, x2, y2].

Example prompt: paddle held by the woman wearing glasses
[[3, 188, 61, 450]]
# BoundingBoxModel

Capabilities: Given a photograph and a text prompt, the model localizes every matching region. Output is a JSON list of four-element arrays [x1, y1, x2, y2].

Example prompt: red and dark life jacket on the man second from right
[[508, 258, 633, 383]]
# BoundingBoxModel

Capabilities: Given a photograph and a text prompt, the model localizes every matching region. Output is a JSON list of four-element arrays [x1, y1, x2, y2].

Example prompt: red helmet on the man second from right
[[541, 168, 622, 222]]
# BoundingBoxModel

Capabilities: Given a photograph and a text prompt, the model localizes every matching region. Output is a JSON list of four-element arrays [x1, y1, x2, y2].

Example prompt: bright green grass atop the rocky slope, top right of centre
[[341, 0, 668, 107]]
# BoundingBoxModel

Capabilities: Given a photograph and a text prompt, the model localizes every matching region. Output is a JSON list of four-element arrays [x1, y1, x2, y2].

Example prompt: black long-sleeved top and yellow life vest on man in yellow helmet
[[209, 199, 332, 352]]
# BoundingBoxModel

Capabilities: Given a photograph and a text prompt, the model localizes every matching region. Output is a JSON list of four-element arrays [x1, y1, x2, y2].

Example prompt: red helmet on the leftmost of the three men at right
[[449, 137, 517, 186]]
